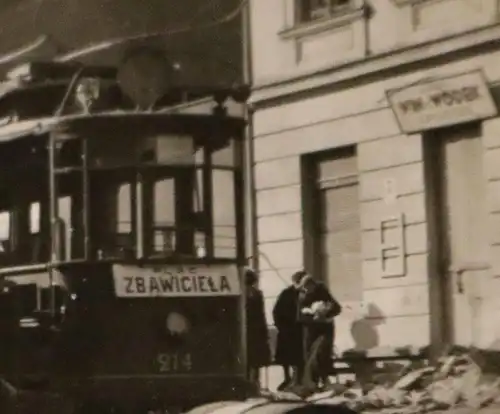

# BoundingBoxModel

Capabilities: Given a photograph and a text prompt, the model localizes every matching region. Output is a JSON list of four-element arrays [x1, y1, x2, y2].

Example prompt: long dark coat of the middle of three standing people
[[273, 286, 303, 366]]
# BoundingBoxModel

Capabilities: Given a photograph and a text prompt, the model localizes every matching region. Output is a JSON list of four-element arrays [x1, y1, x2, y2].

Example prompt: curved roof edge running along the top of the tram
[[0, 111, 245, 144]]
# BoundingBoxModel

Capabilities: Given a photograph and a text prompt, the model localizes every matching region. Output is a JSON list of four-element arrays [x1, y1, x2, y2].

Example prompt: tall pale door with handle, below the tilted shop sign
[[424, 124, 489, 346]]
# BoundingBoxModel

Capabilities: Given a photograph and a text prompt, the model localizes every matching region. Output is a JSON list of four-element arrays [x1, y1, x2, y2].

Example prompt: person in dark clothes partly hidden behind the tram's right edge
[[245, 269, 271, 382]]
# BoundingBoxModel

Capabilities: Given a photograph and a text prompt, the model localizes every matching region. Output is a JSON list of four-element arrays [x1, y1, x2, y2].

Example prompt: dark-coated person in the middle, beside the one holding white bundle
[[273, 271, 306, 391]]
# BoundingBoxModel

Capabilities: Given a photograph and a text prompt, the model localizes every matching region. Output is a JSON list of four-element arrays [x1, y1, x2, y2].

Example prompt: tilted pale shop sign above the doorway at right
[[387, 70, 498, 133]]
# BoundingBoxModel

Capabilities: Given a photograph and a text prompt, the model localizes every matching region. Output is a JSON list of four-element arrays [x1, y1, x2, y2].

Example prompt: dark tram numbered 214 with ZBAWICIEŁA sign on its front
[[0, 61, 251, 413]]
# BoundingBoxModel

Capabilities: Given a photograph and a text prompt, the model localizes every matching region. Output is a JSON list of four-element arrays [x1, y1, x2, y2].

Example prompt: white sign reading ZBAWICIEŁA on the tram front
[[113, 265, 241, 298]]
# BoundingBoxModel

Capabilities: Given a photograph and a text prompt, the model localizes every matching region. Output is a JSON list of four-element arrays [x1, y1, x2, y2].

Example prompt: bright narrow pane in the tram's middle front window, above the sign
[[153, 177, 176, 254]]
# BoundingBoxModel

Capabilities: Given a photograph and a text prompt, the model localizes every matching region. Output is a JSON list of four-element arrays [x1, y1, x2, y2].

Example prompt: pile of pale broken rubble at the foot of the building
[[270, 352, 500, 414]]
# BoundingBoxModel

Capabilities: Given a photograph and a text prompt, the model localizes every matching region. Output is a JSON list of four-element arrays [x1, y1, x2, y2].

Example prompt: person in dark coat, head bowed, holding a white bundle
[[299, 275, 342, 386]]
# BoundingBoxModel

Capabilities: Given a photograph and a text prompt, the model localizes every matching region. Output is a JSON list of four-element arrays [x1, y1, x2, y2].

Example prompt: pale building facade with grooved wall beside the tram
[[250, 0, 500, 353]]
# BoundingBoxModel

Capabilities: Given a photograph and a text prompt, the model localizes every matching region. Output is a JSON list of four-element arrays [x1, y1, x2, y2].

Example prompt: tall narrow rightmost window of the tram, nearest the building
[[212, 169, 237, 258]]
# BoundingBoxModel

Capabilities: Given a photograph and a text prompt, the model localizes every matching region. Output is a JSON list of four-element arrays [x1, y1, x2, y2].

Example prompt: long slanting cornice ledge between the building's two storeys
[[249, 23, 500, 109]]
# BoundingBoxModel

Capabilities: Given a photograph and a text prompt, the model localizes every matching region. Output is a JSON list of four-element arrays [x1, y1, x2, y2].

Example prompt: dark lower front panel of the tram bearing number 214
[[45, 265, 248, 401]]
